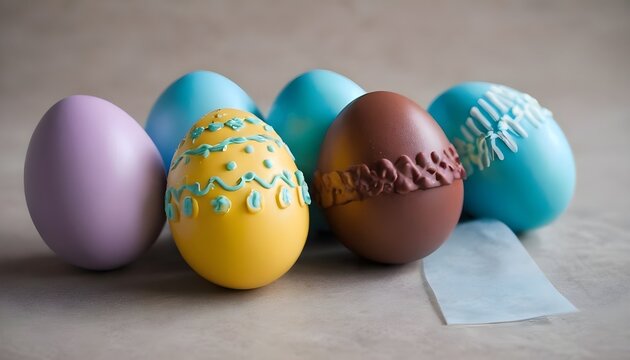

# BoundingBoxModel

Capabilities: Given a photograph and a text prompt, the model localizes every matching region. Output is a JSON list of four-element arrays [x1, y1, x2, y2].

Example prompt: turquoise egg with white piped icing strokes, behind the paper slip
[[429, 82, 576, 231]]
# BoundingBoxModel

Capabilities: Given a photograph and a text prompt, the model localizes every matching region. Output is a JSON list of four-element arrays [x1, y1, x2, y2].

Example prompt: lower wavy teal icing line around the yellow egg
[[164, 170, 299, 212]]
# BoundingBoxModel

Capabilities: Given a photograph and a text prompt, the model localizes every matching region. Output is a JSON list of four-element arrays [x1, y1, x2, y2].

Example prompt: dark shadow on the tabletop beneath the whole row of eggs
[[0, 228, 424, 307]]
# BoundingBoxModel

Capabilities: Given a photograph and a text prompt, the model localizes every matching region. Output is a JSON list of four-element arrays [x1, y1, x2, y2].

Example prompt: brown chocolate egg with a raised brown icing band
[[315, 91, 466, 264]]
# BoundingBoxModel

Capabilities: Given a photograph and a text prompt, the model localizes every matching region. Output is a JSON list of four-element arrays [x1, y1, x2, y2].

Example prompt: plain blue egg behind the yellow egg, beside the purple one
[[145, 70, 262, 171]]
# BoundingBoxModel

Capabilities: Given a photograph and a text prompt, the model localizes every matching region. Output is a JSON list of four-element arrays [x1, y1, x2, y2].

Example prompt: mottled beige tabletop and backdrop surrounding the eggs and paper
[[0, 0, 630, 360]]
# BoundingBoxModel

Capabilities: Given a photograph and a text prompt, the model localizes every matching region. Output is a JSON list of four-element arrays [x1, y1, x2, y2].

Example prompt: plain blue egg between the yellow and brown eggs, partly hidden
[[267, 70, 365, 182]]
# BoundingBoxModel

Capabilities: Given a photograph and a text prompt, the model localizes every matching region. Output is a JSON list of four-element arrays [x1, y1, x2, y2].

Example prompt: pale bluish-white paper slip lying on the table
[[423, 220, 577, 325]]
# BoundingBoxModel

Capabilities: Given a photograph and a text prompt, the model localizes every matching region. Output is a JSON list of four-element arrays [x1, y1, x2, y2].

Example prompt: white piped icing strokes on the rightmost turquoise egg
[[453, 85, 552, 175]]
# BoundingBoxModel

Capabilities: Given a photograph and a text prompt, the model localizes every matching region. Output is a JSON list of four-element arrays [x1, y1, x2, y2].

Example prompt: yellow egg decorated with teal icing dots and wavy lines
[[164, 109, 311, 289]]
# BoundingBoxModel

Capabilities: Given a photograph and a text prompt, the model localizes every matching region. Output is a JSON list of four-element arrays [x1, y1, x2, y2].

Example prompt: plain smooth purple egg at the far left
[[24, 95, 166, 270]]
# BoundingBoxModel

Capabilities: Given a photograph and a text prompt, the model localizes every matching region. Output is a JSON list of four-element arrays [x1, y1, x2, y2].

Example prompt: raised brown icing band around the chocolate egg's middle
[[314, 145, 466, 208]]
